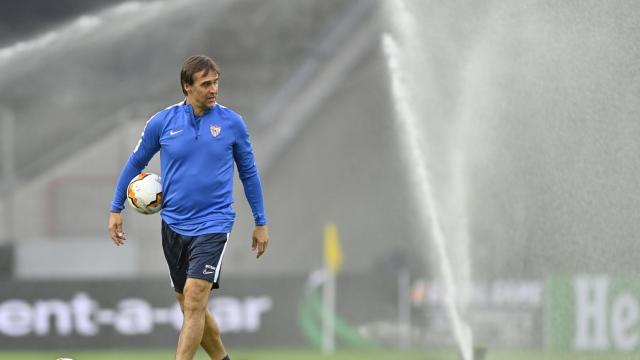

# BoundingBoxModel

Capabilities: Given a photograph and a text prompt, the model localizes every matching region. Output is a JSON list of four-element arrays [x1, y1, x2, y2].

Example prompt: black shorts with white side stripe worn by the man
[[162, 221, 229, 294]]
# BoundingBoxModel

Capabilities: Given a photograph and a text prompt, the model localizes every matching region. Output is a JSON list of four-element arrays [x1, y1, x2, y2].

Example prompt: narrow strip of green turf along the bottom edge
[[0, 350, 640, 360]]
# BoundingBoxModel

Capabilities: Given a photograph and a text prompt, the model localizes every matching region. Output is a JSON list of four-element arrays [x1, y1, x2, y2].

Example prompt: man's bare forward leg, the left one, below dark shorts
[[176, 278, 224, 360]]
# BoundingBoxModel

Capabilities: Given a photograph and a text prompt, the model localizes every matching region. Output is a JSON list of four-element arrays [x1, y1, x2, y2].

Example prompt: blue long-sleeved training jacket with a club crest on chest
[[111, 101, 267, 236]]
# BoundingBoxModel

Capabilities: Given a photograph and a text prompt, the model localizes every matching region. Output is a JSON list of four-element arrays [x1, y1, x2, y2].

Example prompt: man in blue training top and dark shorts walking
[[109, 55, 269, 360]]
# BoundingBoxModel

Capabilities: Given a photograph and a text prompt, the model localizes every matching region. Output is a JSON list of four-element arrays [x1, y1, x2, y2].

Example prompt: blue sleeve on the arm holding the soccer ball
[[111, 114, 162, 212]]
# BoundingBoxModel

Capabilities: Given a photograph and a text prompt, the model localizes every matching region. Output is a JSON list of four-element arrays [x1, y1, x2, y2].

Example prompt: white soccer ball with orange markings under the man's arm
[[127, 172, 162, 215]]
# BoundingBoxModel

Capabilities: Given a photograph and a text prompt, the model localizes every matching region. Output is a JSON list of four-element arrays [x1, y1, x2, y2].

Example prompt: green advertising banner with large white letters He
[[545, 275, 640, 352]]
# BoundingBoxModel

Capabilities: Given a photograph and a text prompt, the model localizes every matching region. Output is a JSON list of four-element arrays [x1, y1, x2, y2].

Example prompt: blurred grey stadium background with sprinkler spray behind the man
[[0, 0, 640, 360]]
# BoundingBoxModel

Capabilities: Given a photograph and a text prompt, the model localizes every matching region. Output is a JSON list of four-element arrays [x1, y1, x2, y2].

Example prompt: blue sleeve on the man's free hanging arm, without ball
[[233, 119, 267, 226]]
